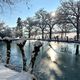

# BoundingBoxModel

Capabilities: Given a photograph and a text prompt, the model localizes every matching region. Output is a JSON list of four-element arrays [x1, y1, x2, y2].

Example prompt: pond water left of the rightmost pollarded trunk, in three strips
[[0, 41, 34, 70]]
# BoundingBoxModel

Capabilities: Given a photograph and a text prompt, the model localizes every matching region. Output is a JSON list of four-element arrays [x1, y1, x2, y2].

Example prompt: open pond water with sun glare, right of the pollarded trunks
[[35, 42, 80, 80]]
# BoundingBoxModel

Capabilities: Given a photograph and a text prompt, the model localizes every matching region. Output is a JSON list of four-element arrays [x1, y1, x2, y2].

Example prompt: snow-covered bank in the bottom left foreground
[[0, 64, 36, 80]]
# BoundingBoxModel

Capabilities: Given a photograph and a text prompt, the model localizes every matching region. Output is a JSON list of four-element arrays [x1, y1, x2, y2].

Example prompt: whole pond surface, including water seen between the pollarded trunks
[[0, 40, 80, 80]]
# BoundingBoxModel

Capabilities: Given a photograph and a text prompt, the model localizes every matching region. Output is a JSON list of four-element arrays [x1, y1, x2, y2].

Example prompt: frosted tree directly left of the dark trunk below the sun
[[35, 9, 47, 39]]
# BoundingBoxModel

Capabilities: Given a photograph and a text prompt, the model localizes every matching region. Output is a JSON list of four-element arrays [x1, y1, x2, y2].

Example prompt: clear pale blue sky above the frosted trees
[[0, 0, 60, 27]]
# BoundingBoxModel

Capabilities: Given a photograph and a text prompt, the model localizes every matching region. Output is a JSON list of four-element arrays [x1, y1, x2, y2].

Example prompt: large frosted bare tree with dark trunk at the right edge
[[57, 0, 80, 40]]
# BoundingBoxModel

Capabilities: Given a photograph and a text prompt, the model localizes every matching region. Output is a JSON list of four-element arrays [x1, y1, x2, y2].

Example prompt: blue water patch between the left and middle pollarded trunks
[[10, 42, 23, 68]]
